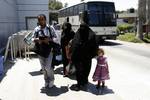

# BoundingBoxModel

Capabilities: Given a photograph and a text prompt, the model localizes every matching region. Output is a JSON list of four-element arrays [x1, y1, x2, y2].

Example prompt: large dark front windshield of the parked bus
[[87, 2, 116, 26]]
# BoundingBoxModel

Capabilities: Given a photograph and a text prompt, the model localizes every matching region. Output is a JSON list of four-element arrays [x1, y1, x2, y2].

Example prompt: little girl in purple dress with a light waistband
[[93, 48, 109, 89]]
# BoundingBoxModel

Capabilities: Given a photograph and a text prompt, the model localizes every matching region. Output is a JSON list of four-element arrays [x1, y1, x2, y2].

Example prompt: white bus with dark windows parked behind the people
[[58, 1, 118, 41]]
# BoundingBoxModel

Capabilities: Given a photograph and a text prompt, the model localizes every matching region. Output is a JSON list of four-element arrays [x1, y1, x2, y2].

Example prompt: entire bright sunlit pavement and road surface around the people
[[0, 41, 150, 100]]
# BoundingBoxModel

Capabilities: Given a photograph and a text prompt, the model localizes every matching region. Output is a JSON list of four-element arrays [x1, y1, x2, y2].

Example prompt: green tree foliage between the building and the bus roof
[[49, 1, 63, 10]]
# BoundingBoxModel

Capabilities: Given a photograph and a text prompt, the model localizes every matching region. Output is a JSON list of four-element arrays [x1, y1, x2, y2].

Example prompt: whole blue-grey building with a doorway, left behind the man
[[0, 0, 49, 53]]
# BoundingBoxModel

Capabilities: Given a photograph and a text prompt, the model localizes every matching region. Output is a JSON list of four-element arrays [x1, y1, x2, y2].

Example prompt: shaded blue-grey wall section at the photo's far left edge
[[0, 0, 17, 52]]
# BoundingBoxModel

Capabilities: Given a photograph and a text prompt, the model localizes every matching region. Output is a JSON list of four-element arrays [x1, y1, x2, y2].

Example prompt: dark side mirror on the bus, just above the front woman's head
[[79, 11, 88, 24]]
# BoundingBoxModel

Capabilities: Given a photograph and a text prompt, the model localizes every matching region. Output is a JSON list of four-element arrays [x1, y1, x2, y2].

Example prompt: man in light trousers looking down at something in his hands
[[33, 14, 56, 88]]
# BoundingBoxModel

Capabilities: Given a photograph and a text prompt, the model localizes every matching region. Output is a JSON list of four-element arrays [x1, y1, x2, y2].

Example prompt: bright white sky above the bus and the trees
[[59, 0, 138, 11]]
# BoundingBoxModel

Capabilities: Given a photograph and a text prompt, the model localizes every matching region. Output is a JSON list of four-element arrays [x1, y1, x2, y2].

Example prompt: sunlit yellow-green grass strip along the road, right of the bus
[[117, 33, 143, 43]]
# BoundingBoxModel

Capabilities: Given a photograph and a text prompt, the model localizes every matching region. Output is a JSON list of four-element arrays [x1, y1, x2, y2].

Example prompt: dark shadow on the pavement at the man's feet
[[41, 86, 68, 96]]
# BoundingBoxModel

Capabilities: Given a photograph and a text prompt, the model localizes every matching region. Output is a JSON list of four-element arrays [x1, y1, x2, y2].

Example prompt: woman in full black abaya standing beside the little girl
[[71, 23, 98, 91]]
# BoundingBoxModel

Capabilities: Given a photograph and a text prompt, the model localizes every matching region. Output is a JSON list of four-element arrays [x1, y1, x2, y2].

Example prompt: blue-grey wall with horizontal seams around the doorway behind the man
[[17, 0, 49, 30]]
